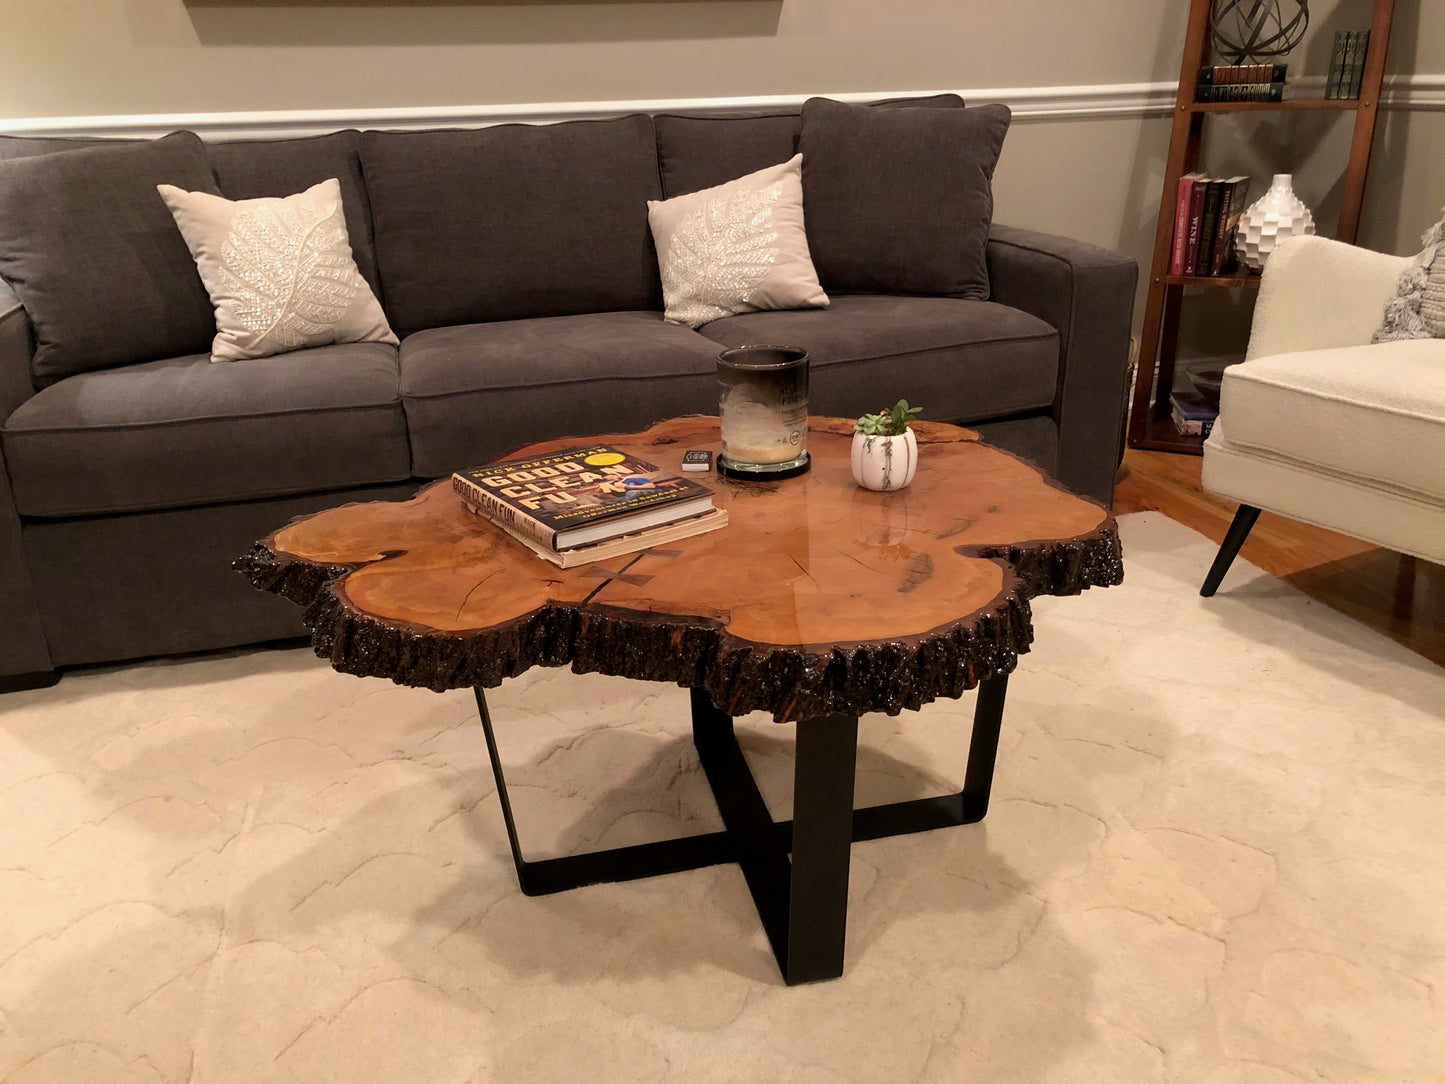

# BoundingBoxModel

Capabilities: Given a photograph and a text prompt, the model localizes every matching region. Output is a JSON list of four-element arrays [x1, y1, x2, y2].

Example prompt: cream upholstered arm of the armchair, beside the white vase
[[1244, 237, 1412, 360]]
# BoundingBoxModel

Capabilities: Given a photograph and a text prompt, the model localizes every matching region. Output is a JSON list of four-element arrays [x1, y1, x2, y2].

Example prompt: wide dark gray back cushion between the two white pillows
[[361, 116, 662, 335]]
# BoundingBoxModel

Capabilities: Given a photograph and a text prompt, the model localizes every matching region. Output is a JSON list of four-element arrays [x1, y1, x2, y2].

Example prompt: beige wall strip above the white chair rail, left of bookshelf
[[0, 0, 1183, 117]]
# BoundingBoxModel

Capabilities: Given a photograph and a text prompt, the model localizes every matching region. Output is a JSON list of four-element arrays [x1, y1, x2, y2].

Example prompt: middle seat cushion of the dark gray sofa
[[402, 312, 721, 477]]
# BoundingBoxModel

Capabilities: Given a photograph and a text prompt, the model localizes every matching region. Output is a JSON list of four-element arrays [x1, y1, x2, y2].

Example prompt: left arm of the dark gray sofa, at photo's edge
[[0, 280, 52, 691]]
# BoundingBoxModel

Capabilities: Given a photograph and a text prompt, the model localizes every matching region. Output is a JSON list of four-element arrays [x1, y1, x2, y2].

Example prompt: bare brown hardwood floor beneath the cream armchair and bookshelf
[[1114, 448, 1445, 666]]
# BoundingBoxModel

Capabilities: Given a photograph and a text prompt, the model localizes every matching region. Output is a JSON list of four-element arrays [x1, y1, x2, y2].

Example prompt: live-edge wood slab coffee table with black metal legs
[[237, 418, 1123, 983]]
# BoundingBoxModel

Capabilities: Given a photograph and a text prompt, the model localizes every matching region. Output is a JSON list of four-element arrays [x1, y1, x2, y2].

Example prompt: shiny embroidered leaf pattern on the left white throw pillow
[[220, 190, 363, 350]]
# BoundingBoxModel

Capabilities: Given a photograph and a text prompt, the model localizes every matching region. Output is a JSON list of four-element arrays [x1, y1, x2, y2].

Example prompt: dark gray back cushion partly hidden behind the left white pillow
[[205, 130, 381, 296]]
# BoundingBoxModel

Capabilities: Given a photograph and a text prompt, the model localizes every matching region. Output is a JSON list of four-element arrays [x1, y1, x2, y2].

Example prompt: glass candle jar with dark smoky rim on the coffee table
[[718, 347, 808, 478]]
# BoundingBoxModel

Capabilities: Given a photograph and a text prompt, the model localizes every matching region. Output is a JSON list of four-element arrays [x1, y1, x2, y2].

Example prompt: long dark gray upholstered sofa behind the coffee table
[[0, 98, 1137, 688]]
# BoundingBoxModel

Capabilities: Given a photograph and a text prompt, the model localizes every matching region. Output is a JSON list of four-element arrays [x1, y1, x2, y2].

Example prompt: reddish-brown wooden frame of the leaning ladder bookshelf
[[1129, 0, 1394, 455]]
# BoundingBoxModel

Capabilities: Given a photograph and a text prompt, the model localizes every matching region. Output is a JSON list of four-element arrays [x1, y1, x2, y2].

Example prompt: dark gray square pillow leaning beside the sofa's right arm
[[799, 98, 1012, 299]]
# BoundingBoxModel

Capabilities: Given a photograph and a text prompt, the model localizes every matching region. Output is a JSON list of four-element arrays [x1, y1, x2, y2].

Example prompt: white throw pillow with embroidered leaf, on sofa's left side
[[156, 179, 396, 361]]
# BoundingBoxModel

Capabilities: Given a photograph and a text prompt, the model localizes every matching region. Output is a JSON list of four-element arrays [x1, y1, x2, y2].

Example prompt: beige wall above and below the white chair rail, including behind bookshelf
[[0, 0, 1445, 356]]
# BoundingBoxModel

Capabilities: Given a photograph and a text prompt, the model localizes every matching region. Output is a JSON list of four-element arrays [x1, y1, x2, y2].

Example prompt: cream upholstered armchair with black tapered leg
[[1199, 237, 1445, 595]]
